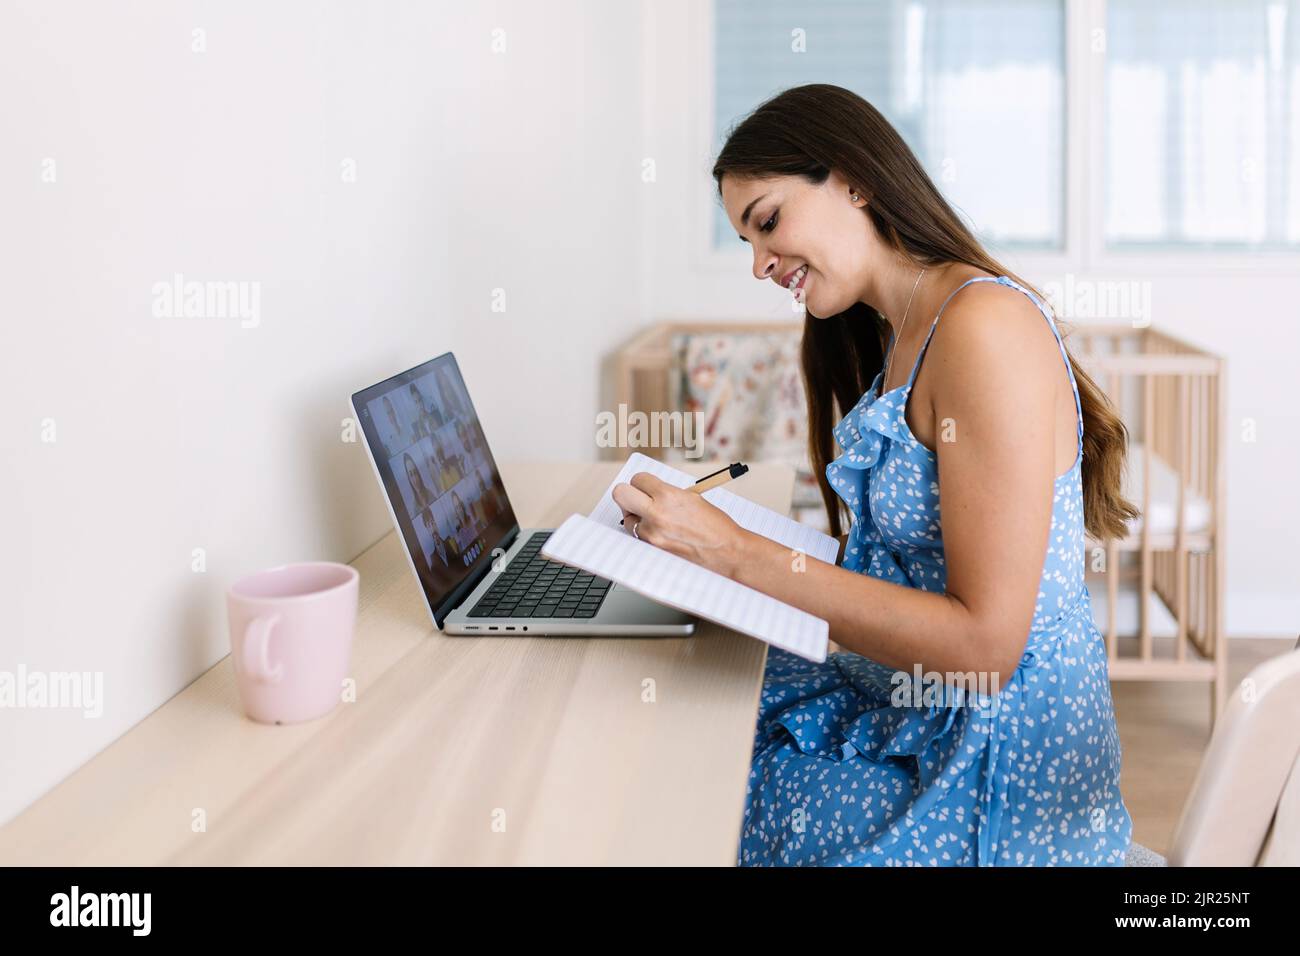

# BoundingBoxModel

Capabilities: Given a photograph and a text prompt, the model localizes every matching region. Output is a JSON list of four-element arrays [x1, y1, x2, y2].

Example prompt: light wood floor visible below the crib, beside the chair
[[1110, 637, 1295, 853]]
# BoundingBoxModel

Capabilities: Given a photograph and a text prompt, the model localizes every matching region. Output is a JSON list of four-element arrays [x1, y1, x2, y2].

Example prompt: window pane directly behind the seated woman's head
[[714, 0, 1065, 250]]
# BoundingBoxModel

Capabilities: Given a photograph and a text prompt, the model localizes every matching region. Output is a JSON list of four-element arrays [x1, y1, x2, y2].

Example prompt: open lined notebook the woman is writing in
[[542, 453, 840, 662]]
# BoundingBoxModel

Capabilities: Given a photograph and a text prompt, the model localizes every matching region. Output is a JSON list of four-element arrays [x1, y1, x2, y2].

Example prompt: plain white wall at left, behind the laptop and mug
[[0, 0, 642, 821]]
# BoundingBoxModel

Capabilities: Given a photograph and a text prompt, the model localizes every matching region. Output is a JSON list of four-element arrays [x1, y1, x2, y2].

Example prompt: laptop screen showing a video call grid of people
[[352, 352, 519, 627]]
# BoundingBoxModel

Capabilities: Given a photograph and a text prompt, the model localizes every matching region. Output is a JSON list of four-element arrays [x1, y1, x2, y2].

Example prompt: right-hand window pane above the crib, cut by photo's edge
[[1105, 0, 1300, 250]]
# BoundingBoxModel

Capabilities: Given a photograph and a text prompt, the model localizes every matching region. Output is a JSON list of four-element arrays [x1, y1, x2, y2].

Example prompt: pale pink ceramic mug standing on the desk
[[226, 561, 360, 723]]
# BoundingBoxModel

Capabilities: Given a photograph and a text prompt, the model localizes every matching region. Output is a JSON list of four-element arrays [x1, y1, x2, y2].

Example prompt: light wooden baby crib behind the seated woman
[[612, 321, 1227, 724]]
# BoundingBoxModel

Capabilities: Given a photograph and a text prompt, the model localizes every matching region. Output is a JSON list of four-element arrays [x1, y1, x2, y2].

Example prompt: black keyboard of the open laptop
[[469, 531, 610, 618]]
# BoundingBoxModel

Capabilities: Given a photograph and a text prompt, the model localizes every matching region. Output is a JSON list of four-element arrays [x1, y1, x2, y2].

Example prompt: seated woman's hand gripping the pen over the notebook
[[614, 471, 749, 578]]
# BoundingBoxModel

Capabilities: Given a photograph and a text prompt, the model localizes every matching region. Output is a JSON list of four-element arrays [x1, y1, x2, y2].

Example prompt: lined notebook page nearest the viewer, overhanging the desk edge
[[542, 512, 833, 663]]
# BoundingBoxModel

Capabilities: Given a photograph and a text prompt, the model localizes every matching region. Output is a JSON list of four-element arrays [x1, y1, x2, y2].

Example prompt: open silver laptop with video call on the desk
[[352, 352, 696, 637]]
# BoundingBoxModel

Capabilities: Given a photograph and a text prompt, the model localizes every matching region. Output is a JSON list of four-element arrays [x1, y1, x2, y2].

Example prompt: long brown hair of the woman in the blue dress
[[714, 83, 1139, 541]]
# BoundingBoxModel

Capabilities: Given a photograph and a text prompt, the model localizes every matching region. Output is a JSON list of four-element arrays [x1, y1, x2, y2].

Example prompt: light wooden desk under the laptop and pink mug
[[0, 463, 794, 865]]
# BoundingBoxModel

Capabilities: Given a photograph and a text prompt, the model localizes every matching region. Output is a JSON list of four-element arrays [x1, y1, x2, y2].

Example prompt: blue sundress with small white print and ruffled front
[[737, 276, 1132, 866]]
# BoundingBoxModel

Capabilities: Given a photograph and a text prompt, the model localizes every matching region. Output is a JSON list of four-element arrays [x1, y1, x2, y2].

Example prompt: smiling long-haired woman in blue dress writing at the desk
[[614, 85, 1135, 865]]
